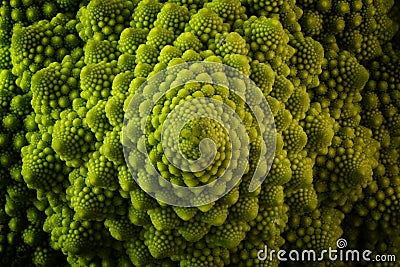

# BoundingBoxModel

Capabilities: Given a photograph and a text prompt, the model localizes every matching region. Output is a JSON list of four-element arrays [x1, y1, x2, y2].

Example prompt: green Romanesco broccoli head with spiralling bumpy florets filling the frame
[[0, 0, 400, 267]]
